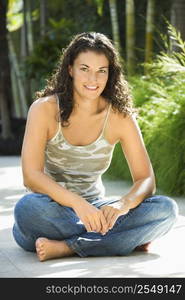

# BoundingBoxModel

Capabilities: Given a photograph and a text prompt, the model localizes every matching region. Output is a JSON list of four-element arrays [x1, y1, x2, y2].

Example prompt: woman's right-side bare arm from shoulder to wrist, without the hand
[[120, 112, 156, 208]]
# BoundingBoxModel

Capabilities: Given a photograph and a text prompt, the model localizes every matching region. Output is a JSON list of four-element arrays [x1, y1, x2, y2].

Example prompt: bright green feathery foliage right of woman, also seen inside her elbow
[[107, 25, 185, 195]]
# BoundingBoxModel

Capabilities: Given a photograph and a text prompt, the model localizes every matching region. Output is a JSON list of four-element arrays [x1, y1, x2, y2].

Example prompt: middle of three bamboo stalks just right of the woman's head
[[126, 0, 135, 75]]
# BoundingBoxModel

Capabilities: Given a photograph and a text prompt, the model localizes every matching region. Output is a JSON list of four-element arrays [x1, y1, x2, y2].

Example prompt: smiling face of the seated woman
[[69, 51, 109, 100]]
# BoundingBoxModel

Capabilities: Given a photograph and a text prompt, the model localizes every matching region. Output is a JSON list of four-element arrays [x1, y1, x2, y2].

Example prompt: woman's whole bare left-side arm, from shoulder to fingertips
[[21, 99, 107, 233]]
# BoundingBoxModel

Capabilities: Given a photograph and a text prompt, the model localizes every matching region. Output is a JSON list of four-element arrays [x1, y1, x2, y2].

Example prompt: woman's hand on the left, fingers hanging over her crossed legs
[[73, 199, 108, 234]]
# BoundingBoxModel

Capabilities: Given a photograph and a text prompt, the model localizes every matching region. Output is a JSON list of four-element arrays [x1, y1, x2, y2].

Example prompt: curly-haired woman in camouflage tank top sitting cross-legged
[[13, 32, 177, 261]]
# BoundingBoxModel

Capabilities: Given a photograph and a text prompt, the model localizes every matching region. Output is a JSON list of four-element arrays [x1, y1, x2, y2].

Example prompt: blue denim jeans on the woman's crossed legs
[[13, 193, 178, 257]]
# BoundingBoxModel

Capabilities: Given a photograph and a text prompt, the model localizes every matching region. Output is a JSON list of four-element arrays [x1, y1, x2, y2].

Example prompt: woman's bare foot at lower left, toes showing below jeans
[[35, 237, 74, 261]]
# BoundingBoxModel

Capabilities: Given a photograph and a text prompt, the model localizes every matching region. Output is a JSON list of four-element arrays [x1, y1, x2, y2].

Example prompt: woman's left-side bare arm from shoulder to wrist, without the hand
[[21, 102, 81, 207]]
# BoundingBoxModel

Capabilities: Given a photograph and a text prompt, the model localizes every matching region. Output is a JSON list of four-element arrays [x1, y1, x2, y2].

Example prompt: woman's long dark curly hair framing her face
[[36, 32, 134, 126]]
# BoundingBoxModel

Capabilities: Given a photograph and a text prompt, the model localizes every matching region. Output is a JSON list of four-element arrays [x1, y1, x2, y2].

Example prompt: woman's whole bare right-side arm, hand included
[[102, 116, 156, 228]]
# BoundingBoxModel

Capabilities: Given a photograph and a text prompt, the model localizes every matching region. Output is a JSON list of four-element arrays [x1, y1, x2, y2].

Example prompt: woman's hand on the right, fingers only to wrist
[[100, 199, 130, 230]]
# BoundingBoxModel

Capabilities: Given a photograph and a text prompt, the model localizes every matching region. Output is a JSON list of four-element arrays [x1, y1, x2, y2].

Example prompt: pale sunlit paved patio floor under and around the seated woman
[[0, 156, 185, 278]]
